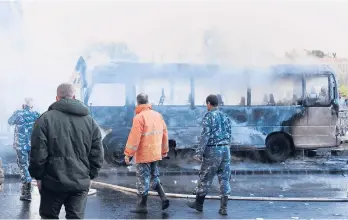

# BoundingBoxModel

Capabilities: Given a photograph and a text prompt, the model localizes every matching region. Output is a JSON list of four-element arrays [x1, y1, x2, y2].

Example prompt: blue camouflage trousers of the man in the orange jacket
[[136, 161, 160, 195]]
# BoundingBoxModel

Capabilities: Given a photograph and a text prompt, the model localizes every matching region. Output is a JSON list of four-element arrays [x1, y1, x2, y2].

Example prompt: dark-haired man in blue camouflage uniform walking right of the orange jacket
[[187, 95, 232, 215]]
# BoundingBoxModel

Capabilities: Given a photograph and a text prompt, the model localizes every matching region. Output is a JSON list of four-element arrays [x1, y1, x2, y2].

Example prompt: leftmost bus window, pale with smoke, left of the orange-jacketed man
[[88, 83, 126, 106]]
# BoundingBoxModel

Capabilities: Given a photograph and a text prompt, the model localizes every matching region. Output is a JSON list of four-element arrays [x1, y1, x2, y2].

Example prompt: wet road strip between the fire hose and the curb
[[96, 174, 348, 198]]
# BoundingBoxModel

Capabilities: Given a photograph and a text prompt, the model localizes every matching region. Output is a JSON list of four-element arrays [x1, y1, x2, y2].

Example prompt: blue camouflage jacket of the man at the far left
[[8, 107, 40, 150]]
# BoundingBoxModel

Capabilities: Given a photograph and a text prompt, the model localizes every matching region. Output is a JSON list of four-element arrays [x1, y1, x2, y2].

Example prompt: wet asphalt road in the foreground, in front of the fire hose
[[0, 180, 348, 219]]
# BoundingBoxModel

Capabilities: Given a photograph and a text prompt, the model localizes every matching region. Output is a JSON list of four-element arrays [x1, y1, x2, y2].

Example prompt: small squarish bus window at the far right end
[[306, 76, 330, 106]]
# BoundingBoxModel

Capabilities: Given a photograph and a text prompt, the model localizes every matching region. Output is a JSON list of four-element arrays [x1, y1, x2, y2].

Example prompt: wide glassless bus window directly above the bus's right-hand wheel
[[251, 76, 302, 106]]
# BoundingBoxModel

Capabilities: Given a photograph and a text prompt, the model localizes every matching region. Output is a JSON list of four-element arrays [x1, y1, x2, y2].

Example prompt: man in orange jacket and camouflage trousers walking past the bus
[[124, 94, 169, 213]]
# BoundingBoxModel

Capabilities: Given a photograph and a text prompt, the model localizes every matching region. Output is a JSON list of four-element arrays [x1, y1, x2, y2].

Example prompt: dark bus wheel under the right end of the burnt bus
[[265, 134, 292, 163]]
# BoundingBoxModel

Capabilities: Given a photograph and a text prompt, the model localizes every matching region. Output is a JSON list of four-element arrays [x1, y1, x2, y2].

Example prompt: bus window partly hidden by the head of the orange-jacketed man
[[137, 79, 191, 105]]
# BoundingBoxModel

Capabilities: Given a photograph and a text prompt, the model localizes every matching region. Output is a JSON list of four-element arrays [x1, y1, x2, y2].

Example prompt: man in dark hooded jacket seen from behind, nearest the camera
[[29, 84, 104, 219]]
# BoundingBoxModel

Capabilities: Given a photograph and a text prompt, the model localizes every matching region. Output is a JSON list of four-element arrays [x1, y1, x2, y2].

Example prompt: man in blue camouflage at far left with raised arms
[[8, 98, 40, 201]]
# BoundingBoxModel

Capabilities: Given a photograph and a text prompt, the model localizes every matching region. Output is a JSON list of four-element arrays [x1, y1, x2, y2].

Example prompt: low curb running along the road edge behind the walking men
[[5, 168, 348, 178]]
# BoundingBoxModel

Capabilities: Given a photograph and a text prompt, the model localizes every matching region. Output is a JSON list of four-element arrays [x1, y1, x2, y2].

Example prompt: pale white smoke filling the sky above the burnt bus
[[0, 0, 348, 170]]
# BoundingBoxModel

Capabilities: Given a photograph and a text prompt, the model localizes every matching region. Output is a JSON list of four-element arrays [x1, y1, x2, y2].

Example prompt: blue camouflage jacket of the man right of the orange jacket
[[196, 109, 232, 157]]
